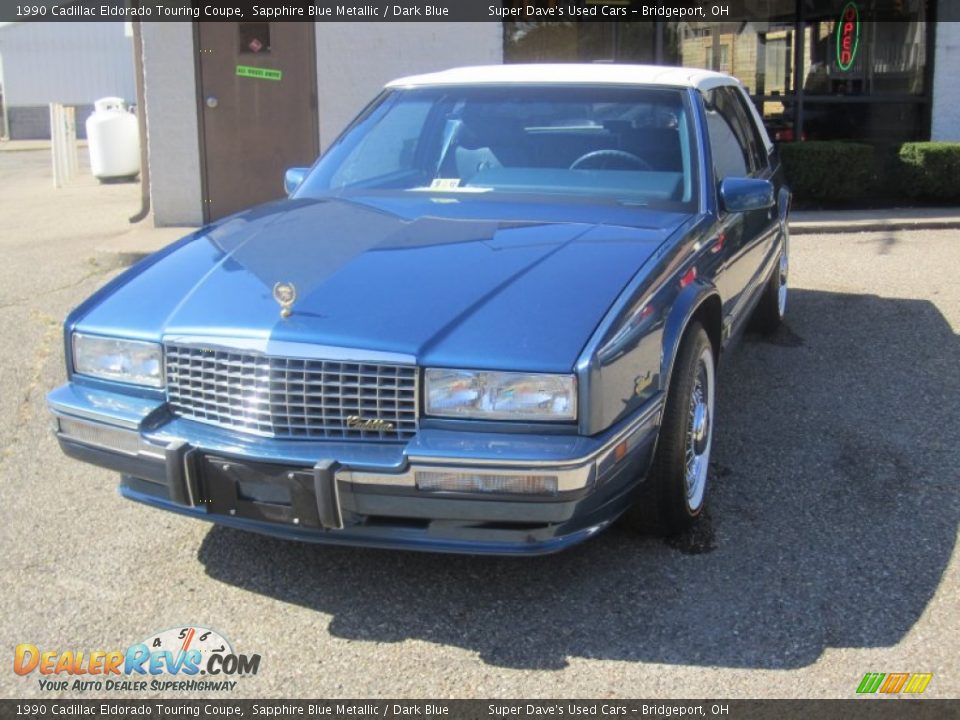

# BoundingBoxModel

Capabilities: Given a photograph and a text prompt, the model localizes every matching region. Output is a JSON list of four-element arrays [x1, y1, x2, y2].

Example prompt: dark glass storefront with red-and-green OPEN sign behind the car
[[504, 0, 935, 142]]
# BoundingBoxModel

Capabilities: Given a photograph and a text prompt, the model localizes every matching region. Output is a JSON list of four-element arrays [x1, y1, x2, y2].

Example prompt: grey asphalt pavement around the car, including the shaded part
[[0, 151, 960, 698]]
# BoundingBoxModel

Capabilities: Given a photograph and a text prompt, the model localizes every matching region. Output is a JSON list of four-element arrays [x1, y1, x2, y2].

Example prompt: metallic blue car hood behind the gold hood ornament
[[77, 196, 688, 372]]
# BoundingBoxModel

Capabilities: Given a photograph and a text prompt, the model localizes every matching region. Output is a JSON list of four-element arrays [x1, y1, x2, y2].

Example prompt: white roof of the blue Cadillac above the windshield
[[387, 63, 737, 90]]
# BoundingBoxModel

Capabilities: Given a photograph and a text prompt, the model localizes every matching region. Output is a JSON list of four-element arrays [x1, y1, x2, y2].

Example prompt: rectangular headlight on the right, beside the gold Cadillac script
[[424, 368, 577, 421]]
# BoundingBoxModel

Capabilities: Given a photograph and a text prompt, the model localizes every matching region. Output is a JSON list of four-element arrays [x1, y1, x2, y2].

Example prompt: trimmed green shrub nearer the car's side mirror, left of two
[[779, 140, 875, 204]]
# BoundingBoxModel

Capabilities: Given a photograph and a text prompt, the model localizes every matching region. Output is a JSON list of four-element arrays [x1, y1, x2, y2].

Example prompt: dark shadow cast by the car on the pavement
[[199, 290, 960, 669]]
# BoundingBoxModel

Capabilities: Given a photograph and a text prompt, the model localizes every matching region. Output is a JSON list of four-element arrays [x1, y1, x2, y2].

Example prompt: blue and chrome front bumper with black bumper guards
[[48, 383, 661, 554]]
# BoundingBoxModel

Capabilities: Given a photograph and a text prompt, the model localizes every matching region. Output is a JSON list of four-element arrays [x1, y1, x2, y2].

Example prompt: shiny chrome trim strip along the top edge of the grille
[[163, 335, 417, 365]]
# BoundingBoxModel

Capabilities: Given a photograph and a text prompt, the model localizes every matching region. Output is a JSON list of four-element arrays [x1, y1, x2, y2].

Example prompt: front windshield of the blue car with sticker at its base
[[295, 85, 696, 210]]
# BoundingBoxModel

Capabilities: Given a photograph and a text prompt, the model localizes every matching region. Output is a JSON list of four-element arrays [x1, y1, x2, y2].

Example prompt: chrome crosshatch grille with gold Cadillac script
[[165, 344, 417, 441]]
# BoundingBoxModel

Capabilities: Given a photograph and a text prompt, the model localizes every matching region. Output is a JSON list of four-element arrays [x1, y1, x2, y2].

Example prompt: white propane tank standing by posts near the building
[[86, 98, 140, 182]]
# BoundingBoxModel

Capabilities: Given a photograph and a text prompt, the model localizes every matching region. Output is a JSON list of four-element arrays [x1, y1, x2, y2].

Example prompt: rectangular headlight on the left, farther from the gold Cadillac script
[[73, 333, 164, 387]]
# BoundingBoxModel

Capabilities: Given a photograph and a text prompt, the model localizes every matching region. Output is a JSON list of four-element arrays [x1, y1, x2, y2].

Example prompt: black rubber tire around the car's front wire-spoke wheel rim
[[626, 321, 716, 535]]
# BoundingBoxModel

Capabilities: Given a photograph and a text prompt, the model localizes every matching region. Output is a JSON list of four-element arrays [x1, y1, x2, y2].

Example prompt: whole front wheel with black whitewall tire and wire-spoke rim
[[628, 322, 716, 535]]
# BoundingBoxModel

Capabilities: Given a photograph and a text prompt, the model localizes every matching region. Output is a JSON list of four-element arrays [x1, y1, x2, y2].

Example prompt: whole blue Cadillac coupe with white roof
[[49, 65, 790, 554]]
